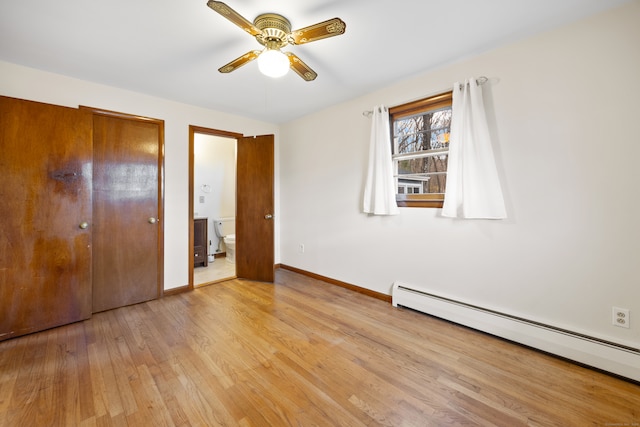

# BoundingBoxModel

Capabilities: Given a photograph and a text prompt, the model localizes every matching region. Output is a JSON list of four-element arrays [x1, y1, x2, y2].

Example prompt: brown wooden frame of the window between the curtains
[[389, 91, 453, 208]]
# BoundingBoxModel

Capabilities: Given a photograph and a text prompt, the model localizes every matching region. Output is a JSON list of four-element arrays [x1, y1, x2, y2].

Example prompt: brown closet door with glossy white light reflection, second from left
[[93, 111, 164, 313]]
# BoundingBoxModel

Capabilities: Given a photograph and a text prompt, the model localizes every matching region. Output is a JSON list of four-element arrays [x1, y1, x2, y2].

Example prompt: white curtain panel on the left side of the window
[[363, 105, 400, 215]]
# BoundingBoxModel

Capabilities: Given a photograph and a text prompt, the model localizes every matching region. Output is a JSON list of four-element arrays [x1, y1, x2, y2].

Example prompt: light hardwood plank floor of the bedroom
[[0, 269, 640, 427]]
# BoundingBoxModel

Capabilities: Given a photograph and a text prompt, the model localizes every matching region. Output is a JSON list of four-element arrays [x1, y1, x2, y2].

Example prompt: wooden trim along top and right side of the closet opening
[[79, 105, 165, 299]]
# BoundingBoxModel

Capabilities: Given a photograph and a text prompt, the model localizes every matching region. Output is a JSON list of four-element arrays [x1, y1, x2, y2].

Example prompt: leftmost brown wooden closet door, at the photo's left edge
[[0, 97, 92, 340]]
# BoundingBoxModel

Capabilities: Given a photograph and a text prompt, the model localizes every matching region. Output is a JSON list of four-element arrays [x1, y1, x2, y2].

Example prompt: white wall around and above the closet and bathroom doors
[[0, 61, 279, 289]]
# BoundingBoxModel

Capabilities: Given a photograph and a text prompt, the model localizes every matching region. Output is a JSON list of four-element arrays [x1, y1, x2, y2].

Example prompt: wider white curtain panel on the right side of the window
[[442, 78, 507, 219]]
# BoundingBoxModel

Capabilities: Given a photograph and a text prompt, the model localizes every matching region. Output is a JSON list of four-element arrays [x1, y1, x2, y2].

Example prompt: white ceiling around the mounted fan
[[0, 0, 629, 123]]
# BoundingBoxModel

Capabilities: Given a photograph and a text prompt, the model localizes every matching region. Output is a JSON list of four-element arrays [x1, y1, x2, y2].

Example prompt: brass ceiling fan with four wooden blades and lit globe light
[[207, 0, 346, 81]]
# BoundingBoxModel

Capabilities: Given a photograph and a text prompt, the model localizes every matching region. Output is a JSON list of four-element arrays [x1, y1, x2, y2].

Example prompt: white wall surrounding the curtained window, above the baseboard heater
[[280, 1, 640, 347]]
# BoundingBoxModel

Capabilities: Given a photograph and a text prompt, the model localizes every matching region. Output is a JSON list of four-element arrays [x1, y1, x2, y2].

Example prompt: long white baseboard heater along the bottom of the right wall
[[392, 282, 640, 381]]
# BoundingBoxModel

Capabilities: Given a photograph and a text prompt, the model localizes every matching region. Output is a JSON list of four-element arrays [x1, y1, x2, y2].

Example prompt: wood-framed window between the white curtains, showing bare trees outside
[[389, 92, 452, 208]]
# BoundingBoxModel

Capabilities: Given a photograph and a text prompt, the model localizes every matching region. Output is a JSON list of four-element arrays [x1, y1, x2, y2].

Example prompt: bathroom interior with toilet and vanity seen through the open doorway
[[193, 133, 236, 286]]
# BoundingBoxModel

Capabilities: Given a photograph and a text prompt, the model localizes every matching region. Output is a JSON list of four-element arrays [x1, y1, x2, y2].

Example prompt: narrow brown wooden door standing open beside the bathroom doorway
[[236, 135, 275, 282]]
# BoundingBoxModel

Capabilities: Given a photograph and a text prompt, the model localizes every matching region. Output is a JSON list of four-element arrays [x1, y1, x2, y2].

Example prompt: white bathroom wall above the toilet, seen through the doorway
[[193, 134, 236, 255]]
